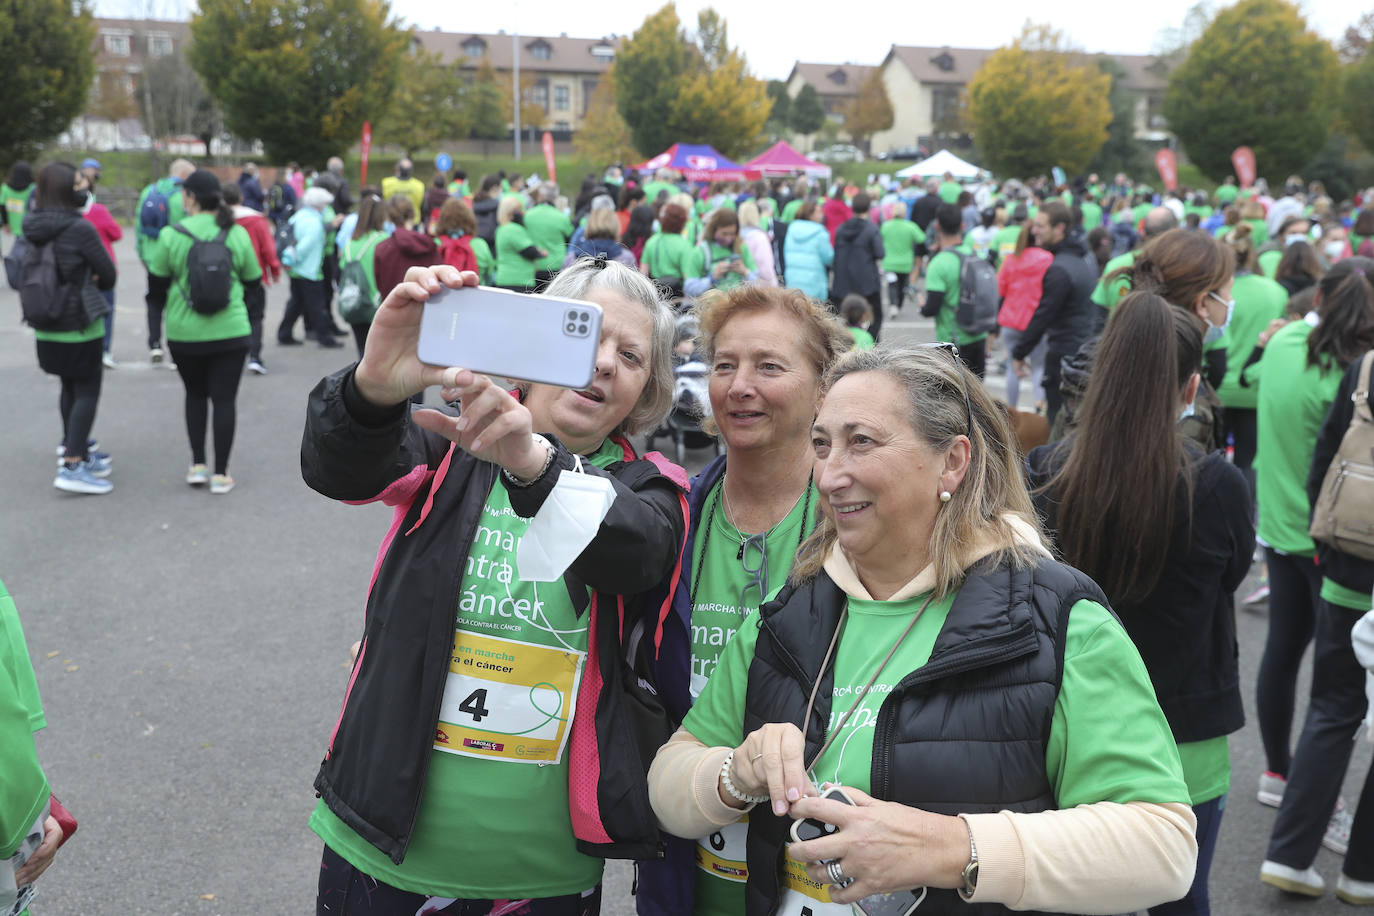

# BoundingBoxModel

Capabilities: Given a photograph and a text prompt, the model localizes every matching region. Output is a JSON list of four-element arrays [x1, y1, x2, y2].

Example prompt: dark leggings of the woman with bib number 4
[[315, 846, 602, 916]]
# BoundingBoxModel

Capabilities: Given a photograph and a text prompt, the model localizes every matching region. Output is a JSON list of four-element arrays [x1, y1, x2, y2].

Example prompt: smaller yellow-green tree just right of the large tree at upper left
[[372, 49, 471, 158]]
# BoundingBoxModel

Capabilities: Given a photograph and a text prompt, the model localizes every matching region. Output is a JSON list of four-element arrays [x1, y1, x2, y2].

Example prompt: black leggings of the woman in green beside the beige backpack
[[1254, 548, 1319, 780]]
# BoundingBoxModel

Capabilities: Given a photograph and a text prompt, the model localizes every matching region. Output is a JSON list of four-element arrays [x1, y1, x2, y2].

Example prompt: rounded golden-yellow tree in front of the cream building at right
[[969, 23, 1112, 177]]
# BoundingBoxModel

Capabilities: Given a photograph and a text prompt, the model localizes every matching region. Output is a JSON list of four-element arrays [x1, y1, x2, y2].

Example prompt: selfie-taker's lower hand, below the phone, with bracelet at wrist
[[411, 368, 551, 481]]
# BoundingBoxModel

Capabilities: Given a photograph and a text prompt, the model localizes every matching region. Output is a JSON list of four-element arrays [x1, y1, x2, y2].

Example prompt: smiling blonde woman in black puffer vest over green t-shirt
[[649, 347, 1197, 916]]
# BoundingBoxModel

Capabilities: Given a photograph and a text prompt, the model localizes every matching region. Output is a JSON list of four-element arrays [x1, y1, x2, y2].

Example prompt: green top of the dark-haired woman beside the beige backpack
[[1249, 321, 1341, 556]]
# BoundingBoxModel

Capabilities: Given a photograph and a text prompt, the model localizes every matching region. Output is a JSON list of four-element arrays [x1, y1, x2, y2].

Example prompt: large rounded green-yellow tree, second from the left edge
[[190, 0, 406, 163]]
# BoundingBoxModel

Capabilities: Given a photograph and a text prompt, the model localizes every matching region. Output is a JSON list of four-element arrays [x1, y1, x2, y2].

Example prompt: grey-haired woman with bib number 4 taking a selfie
[[301, 261, 686, 916]]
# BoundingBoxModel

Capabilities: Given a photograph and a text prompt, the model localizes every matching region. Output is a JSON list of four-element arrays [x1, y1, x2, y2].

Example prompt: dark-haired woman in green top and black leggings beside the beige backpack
[[1243, 258, 1374, 829]]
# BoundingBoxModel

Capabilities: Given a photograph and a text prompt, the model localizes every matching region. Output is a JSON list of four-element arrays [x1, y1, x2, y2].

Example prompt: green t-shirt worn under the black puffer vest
[[683, 595, 1189, 916]]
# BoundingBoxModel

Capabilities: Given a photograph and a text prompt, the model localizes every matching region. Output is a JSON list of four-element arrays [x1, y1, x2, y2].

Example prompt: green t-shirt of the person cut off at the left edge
[[0, 582, 49, 860]]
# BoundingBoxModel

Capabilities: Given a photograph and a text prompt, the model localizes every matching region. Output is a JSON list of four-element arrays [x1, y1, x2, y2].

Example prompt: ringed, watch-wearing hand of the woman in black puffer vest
[[787, 786, 969, 904]]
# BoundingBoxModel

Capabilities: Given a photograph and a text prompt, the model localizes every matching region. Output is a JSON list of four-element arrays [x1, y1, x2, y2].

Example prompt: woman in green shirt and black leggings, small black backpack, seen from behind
[[148, 169, 263, 494]]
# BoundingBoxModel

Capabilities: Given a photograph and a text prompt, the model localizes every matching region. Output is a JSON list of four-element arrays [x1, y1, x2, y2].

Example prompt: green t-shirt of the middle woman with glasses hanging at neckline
[[690, 479, 818, 698]]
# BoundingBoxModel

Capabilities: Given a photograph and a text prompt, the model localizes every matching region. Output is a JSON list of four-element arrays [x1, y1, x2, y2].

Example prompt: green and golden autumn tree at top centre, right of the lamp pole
[[613, 3, 772, 157]]
